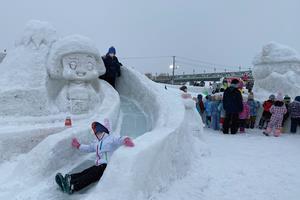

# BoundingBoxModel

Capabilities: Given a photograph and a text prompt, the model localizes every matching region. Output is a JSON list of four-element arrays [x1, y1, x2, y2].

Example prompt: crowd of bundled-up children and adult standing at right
[[190, 79, 300, 137]]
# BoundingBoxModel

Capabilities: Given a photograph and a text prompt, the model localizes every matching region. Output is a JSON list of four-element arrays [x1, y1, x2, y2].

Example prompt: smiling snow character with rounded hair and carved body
[[47, 35, 105, 114]]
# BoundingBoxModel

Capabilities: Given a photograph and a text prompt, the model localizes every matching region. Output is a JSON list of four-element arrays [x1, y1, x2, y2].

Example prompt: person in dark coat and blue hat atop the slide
[[99, 47, 122, 88]]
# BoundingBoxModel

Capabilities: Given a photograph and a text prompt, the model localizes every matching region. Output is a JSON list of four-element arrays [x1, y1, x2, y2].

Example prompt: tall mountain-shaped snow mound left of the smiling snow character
[[0, 21, 57, 116]]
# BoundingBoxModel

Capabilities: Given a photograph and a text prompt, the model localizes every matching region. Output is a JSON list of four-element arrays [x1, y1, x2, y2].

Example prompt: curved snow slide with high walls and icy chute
[[0, 68, 202, 199]]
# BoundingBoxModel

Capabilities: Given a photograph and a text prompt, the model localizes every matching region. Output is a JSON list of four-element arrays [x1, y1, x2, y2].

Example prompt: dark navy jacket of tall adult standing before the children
[[223, 86, 243, 114]]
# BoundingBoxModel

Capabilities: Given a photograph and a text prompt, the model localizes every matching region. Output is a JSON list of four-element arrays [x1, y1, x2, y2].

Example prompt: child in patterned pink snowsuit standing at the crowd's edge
[[263, 93, 287, 137]]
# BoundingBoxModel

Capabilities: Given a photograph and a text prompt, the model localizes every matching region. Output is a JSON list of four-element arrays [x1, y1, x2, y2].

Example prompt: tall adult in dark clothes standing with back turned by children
[[223, 79, 243, 134]]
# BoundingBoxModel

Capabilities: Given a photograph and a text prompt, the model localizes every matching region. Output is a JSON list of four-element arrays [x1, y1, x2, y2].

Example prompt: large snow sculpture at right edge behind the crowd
[[253, 42, 300, 98]]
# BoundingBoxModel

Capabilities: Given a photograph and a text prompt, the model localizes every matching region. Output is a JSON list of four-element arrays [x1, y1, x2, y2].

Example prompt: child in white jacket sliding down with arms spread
[[55, 122, 134, 194]]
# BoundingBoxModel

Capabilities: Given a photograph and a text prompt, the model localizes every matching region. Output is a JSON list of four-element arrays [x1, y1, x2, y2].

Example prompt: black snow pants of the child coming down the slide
[[70, 164, 106, 191]]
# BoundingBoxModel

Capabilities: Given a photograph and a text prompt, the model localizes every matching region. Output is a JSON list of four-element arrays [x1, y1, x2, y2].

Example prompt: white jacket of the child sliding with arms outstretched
[[79, 134, 127, 166]]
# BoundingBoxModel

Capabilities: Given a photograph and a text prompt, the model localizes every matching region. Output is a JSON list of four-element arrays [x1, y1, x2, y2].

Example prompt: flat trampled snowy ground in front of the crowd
[[153, 129, 300, 200]]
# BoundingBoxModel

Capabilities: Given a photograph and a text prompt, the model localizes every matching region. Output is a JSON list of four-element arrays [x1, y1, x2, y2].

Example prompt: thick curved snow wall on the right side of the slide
[[87, 68, 203, 200]]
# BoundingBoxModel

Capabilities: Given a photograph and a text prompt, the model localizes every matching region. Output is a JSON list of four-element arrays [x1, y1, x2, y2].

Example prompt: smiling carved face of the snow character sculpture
[[62, 53, 99, 81]]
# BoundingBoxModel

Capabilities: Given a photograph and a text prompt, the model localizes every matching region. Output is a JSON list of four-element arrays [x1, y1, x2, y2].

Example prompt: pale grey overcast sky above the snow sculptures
[[0, 0, 300, 73]]
